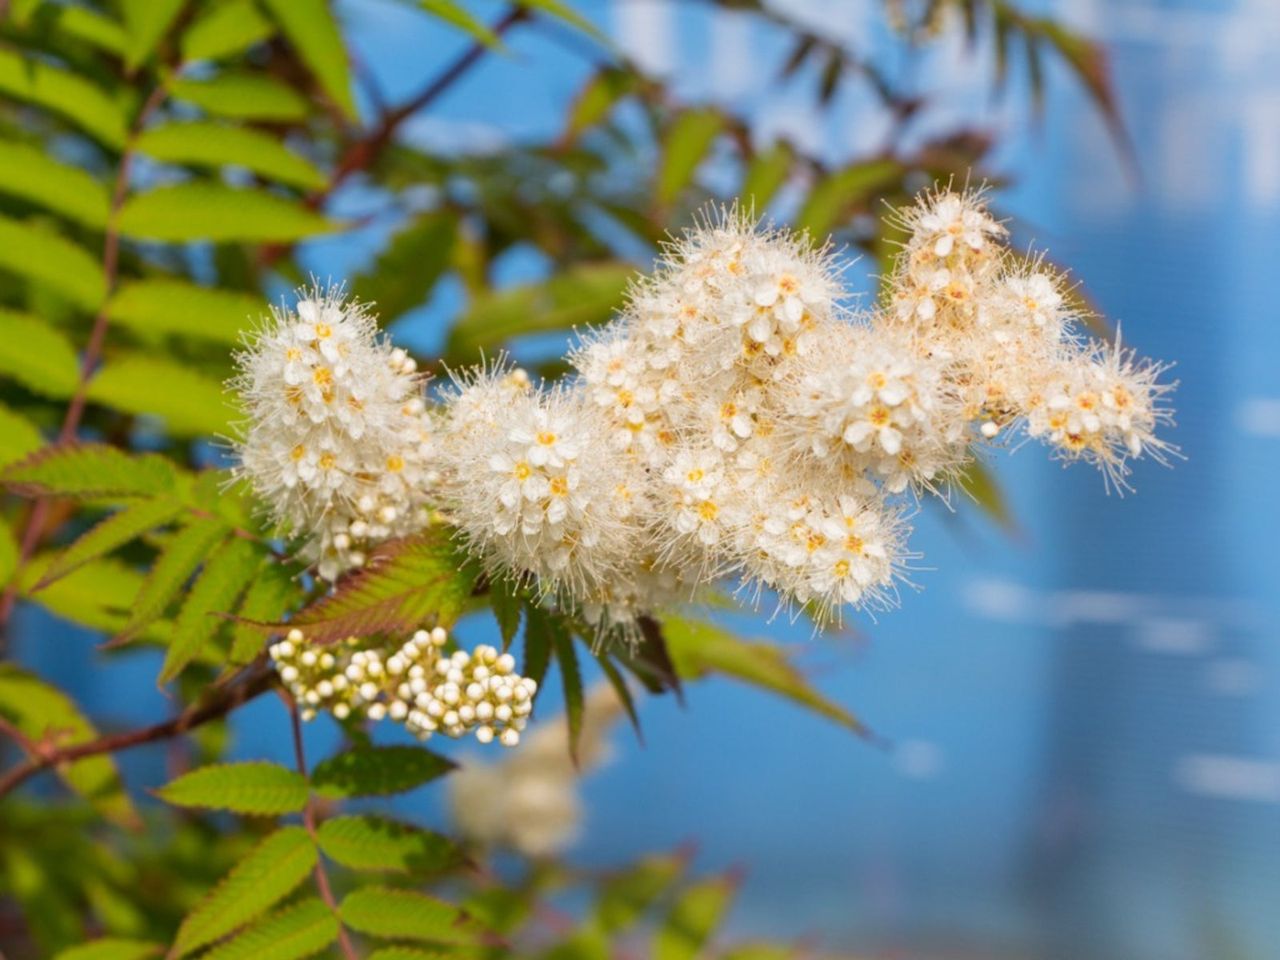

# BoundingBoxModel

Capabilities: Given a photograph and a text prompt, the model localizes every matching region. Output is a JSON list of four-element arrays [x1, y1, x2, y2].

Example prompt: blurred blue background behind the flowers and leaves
[[18, 0, 1280, 960]]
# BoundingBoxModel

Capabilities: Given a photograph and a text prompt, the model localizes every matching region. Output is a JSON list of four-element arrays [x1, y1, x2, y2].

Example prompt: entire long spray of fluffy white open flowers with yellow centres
[[239, 191, 1175, 640]]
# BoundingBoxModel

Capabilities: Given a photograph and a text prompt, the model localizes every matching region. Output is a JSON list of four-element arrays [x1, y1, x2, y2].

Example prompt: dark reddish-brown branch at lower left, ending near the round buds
[[0, 659, 275, 796]]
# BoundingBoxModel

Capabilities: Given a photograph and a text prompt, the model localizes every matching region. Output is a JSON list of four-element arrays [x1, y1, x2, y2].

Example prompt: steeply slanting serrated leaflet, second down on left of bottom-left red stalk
[[170, 827, 316, 957]]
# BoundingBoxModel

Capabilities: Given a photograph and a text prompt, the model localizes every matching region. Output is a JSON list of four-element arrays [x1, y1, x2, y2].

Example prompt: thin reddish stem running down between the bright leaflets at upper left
[[0, 83, 168, 627]]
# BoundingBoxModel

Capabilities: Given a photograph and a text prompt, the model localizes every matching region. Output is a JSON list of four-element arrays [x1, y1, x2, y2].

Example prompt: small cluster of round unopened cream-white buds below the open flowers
[[270, 627, 538, 746]]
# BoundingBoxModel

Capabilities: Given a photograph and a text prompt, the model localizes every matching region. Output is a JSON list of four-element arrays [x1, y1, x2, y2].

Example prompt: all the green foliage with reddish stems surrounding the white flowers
[[0, 0, 1126, 960]]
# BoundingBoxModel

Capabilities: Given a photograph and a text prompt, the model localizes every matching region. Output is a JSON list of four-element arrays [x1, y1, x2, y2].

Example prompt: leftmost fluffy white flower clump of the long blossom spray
[[233, 289, 434, 580]]
